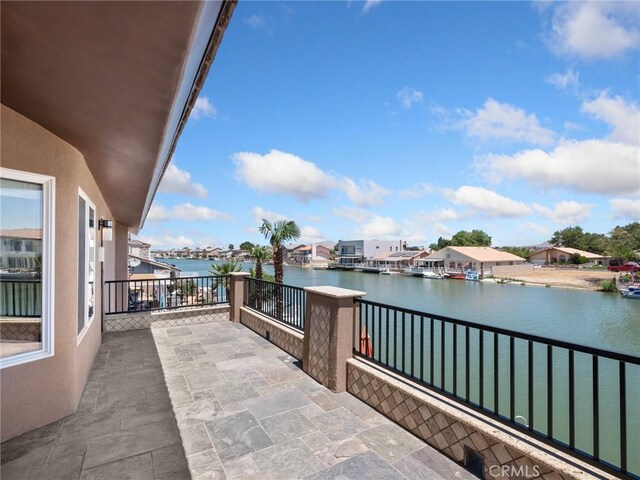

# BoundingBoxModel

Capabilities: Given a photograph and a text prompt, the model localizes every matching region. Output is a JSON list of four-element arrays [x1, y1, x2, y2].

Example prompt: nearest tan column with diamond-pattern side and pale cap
[[302, 287, 366, 392]]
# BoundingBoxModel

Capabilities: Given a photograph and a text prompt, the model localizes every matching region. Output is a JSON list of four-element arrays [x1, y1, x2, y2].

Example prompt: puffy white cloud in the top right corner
[[550, 2, 640, 59]]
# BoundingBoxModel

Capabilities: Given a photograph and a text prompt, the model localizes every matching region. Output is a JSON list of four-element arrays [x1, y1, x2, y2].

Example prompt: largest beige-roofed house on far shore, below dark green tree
[[425, 247, 526, 273]]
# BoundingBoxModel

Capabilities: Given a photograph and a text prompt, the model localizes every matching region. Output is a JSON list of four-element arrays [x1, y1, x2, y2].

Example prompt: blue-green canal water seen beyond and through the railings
[[164, 259, 640, 474]]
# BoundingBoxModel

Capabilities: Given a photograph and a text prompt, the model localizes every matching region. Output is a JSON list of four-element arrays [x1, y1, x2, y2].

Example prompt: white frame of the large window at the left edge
[[0, 167, 56, 370]]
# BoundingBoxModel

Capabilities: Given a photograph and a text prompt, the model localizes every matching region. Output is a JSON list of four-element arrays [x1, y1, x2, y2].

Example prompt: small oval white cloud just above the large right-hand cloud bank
[[460, 98, 555, 146]]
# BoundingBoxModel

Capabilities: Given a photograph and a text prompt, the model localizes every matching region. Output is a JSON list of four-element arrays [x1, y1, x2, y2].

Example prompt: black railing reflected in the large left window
[[0, 279, 42, 318]]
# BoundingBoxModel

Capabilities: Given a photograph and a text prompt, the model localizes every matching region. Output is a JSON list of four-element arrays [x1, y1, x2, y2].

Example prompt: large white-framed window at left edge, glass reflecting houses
[[0, 168, 55, 368]]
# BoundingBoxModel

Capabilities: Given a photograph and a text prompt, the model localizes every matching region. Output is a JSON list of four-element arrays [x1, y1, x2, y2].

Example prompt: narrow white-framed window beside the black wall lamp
[[78, 190, 96, 341]]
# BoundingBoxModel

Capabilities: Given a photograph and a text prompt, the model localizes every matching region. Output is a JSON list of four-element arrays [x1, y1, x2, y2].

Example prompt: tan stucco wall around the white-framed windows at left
[[0, 105, 115, 440]]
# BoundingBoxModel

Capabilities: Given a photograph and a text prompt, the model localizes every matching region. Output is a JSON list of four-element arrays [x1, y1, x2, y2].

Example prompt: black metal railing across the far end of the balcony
[[103, 276, 229, 315]]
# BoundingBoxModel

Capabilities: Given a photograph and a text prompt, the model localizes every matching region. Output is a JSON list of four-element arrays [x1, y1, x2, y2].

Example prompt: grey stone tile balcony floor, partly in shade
[[0, 321, 475, 480]]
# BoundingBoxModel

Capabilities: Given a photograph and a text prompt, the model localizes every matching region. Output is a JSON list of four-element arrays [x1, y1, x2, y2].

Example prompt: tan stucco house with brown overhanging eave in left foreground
[[0, 2, 235, 440]]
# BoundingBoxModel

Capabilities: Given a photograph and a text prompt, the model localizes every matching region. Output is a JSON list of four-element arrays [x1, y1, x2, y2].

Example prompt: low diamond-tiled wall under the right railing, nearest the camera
[[347, 359, 615, 480]]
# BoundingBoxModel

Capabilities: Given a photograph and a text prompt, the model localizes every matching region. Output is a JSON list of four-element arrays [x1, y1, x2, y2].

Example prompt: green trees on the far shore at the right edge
[[549, 222, 640, 263]]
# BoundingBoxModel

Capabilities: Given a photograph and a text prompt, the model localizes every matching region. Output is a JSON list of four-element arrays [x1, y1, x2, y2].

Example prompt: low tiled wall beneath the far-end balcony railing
[[104, 305, 229, 332]]
